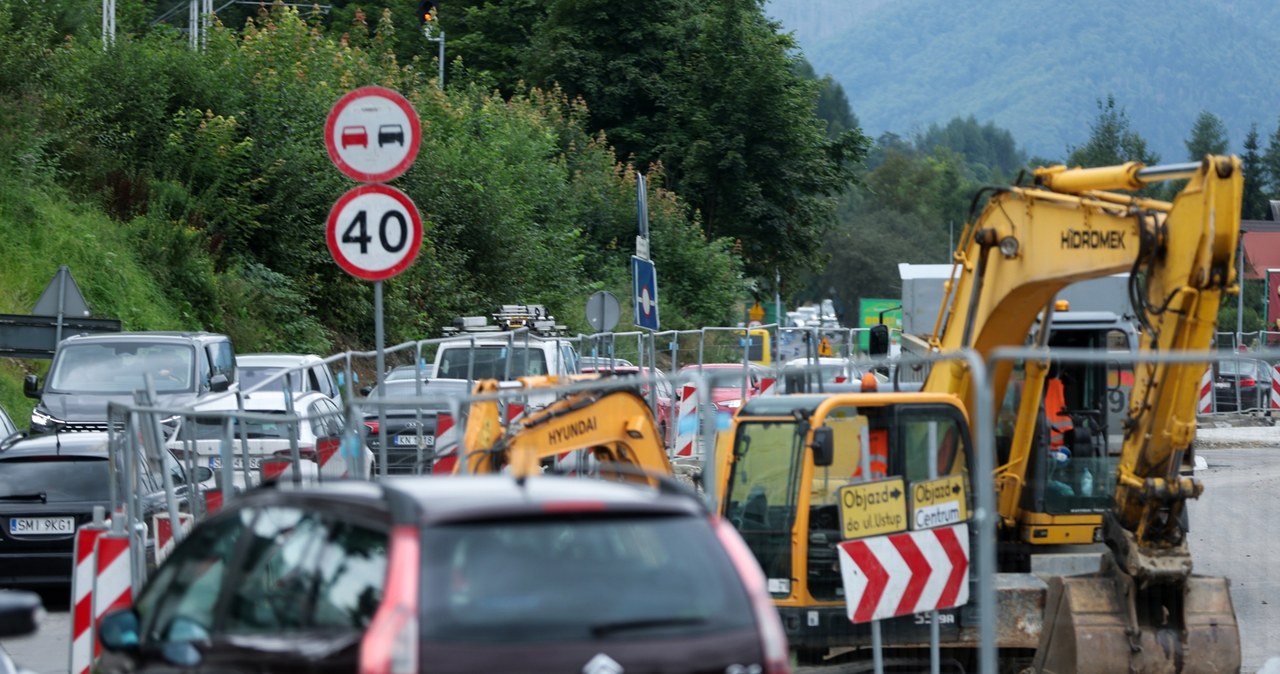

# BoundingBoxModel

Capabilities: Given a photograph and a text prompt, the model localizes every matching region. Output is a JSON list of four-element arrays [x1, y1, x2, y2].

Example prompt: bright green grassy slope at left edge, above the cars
[[0, 175, 192, 427]]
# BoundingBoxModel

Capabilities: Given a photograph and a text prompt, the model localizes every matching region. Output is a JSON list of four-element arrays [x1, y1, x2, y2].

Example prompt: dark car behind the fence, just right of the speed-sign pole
[[365, 379, 471, 474]]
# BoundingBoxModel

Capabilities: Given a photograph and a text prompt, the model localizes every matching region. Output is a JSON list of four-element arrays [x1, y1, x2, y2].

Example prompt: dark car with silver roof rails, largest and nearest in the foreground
[[97, 476, 790, 674]]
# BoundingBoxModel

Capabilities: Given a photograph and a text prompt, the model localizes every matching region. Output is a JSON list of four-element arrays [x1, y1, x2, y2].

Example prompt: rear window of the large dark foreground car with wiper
[[420, 517, 754, 643]]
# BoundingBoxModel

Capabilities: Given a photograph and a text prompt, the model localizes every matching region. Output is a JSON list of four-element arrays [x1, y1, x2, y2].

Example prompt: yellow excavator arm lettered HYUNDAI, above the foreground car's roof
[[454, 375, 672, 478]]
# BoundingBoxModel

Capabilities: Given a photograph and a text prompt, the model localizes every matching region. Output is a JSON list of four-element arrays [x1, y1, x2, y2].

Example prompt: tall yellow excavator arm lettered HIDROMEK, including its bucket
[[924, 156, 1243, 671]]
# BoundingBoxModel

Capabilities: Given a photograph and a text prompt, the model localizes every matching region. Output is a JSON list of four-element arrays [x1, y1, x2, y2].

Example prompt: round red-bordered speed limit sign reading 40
[[325, 184, 422, 281]]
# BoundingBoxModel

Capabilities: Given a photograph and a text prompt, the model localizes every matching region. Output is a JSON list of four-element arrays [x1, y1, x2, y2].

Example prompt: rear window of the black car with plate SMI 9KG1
[[0, 455, 111, 503]]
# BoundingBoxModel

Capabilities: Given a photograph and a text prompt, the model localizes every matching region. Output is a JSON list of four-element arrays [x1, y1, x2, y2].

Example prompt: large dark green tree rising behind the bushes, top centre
[[432, 0, 867, 286]]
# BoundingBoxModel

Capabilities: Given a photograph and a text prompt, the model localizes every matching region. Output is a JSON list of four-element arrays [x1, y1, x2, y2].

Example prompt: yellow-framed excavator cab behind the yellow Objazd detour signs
[[716, 393, 973, 661]]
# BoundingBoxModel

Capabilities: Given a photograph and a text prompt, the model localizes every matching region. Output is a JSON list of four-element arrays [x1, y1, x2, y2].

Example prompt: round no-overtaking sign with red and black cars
[[324, 87, 422, 183]]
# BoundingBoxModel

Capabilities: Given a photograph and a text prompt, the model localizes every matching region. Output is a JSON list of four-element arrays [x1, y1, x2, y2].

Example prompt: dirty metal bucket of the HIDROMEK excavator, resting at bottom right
[[1032, 569, 1240, 674]]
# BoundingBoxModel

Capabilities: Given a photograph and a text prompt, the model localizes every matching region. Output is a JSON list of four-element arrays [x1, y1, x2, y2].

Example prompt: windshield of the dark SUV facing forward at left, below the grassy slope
[[47, 341, 196, 394]]
